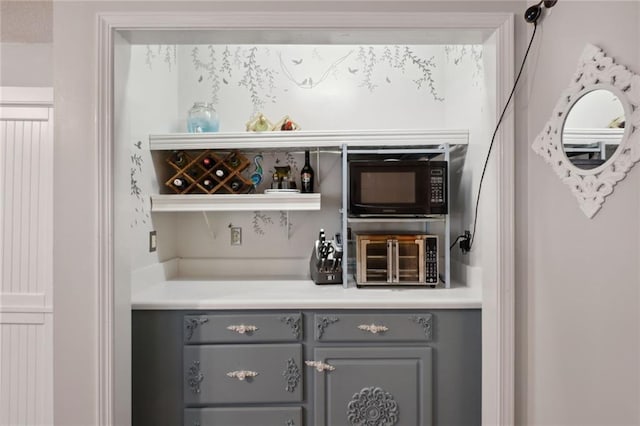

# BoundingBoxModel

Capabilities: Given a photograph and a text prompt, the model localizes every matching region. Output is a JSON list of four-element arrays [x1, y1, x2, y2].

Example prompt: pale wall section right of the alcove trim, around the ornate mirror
[[517, 2, 640, 425]]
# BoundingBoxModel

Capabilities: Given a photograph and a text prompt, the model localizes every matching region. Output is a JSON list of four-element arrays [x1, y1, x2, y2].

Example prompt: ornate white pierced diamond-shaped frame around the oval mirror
[[532, 44, 640, 218]]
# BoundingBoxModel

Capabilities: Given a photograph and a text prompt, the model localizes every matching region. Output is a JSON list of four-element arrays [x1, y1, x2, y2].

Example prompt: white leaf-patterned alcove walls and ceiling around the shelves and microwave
[[114, 29, 496, 286]]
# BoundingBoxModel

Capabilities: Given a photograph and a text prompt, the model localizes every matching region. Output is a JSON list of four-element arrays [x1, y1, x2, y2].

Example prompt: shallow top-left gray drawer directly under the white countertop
[[183, 312, 302, 344]]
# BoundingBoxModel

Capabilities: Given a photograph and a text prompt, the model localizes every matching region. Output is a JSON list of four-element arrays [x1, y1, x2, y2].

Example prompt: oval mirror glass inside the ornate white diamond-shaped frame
[[562, 89, 625, 170]]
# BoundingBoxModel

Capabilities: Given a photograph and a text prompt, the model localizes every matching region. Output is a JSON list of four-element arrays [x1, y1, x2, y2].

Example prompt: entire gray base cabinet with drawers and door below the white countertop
[[132, 309, 481, 426]]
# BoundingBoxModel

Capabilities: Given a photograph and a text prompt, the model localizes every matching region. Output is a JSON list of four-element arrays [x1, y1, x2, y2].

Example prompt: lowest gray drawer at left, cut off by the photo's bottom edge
[[184, 407, 302, 426]]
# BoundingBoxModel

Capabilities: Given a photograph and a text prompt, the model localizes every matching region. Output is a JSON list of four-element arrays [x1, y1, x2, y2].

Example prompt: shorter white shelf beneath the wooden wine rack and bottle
[[151, 193, 320, 212]]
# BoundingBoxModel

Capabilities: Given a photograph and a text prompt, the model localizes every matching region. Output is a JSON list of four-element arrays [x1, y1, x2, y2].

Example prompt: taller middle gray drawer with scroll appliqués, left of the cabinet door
[[183, 343, 303, 405]]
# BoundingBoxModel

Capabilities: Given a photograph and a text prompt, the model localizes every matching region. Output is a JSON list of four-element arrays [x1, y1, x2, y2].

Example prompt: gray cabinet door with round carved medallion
[[314, 347, 433, 426]]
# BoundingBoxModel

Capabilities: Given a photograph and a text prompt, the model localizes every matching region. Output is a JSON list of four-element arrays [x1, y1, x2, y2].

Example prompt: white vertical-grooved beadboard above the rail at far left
[[0, 115, 53, 305]]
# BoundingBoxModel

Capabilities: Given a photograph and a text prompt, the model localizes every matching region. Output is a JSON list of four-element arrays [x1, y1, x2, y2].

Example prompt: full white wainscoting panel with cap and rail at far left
[[0, 87, 53, 426]]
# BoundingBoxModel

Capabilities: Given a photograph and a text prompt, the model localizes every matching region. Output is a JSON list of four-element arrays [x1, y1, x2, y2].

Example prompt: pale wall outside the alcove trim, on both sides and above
[[54, 1, 640, 425]]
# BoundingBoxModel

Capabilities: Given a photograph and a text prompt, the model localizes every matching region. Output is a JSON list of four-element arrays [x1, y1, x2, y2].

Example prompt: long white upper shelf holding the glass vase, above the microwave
[[149, 129, 469, 150]]
